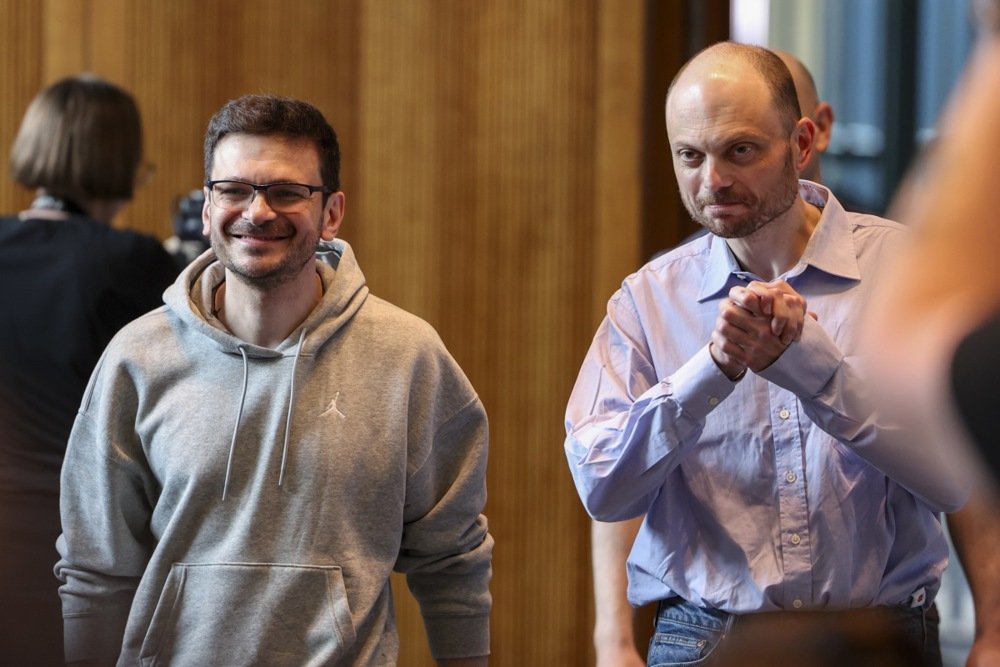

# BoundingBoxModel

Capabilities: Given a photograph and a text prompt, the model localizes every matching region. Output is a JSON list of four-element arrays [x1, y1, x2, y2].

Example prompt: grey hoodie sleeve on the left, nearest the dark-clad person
[[55, 353, 154, 663]]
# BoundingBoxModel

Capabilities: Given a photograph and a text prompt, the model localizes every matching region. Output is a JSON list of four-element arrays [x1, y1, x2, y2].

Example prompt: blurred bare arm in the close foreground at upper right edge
[[888, 39, 1000, 334]]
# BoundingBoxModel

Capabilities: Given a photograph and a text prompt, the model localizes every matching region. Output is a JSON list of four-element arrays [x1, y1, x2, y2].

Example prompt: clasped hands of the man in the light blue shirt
[[708, 280, 816, 380]]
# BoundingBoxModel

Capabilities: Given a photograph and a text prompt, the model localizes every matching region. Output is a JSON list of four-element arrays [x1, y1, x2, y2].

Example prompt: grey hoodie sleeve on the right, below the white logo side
[[396, 362, 493, 660]]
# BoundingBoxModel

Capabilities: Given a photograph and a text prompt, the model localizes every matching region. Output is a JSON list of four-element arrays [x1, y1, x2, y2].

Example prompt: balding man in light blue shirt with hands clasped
[[565, 43, 967, 664]]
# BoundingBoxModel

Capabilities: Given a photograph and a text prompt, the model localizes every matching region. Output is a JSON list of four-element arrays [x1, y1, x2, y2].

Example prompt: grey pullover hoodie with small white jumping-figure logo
[[56, 241, 493, 667]]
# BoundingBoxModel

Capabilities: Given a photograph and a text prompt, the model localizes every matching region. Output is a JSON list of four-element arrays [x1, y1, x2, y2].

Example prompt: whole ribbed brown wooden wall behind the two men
[[0, 0, 680, 666]]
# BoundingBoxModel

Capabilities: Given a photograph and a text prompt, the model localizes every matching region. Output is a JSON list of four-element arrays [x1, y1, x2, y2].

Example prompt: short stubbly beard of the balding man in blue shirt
[[684, 149, 799, 239]]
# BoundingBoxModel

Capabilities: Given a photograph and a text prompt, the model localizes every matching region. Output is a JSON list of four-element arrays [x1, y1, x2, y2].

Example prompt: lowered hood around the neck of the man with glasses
[[163, 239, 368, 358]]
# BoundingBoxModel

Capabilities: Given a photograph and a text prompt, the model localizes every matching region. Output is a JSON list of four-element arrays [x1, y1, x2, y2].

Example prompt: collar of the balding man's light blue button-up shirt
[[698, 181, 861, 301]]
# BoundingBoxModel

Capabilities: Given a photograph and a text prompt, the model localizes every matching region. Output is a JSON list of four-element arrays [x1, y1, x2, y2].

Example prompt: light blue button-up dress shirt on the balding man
[[565, 181, 965, 613]]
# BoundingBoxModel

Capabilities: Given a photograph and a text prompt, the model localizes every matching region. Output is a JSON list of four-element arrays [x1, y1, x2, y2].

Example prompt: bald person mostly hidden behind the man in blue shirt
[[591, 49, 1000, 667]]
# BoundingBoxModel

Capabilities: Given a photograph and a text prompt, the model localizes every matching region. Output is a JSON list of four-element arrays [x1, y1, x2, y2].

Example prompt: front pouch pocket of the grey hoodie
[[140, 563, 355, 667]]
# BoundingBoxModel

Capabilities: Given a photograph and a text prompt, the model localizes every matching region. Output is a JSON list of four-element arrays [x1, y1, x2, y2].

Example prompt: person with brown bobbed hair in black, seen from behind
[[0, 75, 178, 665]]
